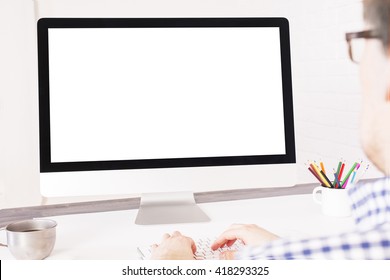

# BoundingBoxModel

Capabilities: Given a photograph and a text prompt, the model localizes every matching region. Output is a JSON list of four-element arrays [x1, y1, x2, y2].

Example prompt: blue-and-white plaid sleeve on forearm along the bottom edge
[[236, 223, 390, 260]]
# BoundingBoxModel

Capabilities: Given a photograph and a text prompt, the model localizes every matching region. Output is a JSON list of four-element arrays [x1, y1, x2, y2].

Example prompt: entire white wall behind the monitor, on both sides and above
[[0, 0, 378, 208]]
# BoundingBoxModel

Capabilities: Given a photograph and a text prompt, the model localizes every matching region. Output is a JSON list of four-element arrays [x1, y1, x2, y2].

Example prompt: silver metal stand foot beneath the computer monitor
[[135, 192, 210, 225]]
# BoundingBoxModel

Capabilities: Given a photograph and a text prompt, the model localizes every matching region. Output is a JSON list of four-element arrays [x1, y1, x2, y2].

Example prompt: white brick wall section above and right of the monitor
[[38, 0, 378, 182]]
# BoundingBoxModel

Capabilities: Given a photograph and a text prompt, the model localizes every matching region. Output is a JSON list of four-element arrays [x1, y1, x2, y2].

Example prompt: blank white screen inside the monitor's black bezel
[[49, 28, 285, 162]]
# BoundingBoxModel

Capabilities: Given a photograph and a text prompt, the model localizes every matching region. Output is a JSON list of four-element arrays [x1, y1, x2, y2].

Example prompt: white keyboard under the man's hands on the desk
[[137, 238, 244, 260]]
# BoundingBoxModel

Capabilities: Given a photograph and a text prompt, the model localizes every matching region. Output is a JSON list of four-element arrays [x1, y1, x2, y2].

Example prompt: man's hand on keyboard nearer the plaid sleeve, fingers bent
[[211, 224, 279, 259]]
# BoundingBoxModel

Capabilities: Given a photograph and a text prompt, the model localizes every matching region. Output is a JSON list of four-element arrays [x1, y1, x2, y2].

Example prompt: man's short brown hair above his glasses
[[363, 0, 390, 48]]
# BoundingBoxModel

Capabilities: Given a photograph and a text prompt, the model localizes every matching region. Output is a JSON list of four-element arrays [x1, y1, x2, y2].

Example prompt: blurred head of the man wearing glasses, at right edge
[[360, 0, 390, 175]]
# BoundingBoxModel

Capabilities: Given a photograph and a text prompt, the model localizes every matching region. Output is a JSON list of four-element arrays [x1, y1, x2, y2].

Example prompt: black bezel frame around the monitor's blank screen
[[38, 18, 296, 172]]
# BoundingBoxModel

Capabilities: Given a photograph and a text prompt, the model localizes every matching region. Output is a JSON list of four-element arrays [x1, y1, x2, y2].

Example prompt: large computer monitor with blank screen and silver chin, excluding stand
[[38, 18, 296, 223]]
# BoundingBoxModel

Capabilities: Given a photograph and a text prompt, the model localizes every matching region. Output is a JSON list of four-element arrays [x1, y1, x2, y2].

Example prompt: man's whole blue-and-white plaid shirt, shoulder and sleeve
[[236, 177, 390, 260]]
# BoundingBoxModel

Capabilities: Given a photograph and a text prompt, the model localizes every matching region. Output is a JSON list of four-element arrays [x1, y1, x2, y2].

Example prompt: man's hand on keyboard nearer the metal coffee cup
[[151, 231, 196, 260]]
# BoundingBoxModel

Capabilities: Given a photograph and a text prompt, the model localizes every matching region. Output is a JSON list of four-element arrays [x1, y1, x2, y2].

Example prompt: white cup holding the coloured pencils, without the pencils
[[313, 186, 351, 217]]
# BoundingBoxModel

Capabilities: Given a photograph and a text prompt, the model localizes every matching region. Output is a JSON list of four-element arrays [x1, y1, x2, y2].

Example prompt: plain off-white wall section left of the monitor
[[0, 0, 40, 208]]
